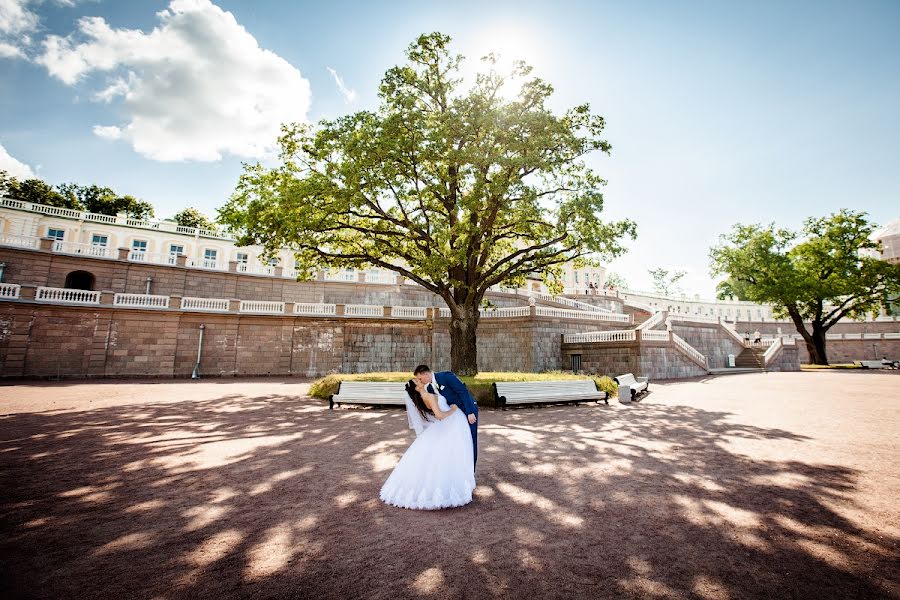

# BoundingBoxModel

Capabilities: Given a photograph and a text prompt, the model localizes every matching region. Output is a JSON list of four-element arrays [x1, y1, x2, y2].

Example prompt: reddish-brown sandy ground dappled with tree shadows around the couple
[[0, 372, 900, 600]]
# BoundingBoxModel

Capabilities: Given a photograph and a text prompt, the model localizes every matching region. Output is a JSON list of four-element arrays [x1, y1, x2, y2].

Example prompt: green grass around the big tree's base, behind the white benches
[[309, 371, 619, 406]]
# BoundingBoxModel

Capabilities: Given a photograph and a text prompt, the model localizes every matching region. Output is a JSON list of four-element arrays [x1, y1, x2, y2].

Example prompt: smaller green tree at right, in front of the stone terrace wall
[[710, 210, 900, 365]]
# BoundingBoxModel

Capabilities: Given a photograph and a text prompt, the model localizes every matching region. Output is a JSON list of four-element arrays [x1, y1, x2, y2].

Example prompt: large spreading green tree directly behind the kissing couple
[[219, 33, 635, 374]]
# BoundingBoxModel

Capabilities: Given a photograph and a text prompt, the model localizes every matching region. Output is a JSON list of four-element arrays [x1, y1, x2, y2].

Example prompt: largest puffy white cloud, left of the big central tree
[[38, 0, 311, 161]]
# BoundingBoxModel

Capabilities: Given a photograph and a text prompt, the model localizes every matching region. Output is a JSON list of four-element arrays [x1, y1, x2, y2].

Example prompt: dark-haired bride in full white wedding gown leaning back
[[381, 379, 475, 510]]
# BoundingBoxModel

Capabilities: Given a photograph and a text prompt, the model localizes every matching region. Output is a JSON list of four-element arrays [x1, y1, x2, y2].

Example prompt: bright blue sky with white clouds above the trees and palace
[[0, 0, 900, 297]]
